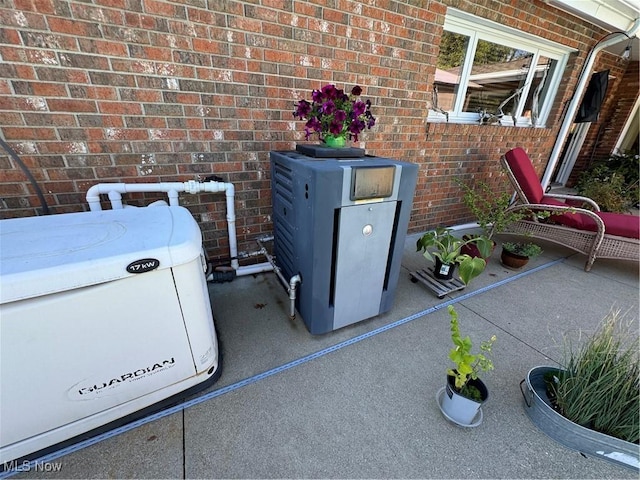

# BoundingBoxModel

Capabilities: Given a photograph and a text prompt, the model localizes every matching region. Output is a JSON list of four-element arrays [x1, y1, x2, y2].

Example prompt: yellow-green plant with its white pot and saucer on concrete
[[438, 305, 496, 427]]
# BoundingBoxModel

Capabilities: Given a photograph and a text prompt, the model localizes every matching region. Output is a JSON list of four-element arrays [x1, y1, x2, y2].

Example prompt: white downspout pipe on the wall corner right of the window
[[541, 18, 640, 190]]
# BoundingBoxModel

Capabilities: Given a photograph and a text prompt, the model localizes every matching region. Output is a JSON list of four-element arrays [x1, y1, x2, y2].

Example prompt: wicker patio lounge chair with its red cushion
[[501, 147, 640, 272]]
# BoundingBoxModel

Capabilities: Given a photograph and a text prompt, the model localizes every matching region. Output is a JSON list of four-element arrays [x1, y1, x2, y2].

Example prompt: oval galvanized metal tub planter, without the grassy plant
[[520, 367, 640, 471]]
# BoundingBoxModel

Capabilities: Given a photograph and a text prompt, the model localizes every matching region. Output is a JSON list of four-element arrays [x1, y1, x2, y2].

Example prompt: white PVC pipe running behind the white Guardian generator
[[86, 180, 244, 271]]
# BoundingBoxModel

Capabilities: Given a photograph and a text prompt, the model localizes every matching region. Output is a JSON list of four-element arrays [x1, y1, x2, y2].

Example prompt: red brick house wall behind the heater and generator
[[0, 0, 620, 262]]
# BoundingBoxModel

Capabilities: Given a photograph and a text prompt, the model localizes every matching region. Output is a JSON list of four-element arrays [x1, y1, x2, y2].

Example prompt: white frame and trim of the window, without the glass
[[428, 8, 576, 127]]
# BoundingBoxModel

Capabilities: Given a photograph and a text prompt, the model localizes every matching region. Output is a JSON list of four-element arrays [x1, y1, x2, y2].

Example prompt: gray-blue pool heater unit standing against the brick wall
[[271, 146, 418, 334]]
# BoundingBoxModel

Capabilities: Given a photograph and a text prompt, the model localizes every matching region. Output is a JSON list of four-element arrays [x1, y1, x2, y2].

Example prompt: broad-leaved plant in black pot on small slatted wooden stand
[[416, 227, 491, 285]]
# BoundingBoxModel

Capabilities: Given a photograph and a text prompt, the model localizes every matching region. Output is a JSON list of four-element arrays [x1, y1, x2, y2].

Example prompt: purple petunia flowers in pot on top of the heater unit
[[293, 85, 376, 147]]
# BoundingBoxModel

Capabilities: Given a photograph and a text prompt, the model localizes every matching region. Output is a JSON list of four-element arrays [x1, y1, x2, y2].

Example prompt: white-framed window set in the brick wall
[[428, 8, 573, 127]]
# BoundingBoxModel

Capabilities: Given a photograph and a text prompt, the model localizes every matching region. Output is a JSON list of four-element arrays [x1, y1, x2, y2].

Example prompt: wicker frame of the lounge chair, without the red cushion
[[501, 156, 640, 272]]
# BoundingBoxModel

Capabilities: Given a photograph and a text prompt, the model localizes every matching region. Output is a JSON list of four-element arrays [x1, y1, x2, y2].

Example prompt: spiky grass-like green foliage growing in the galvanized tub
[[550, 311, 640, 443]]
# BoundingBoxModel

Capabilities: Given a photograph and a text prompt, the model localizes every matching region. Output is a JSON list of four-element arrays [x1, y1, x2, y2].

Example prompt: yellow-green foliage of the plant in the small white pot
[[447, 305, 496, 400]]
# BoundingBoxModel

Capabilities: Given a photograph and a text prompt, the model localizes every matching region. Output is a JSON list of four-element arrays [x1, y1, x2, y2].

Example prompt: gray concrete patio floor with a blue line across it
[[6, 231, 639, 479]]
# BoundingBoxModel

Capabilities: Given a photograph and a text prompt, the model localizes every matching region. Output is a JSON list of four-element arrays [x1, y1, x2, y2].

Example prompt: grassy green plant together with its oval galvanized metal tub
[[520, 311, 640, 472]]
